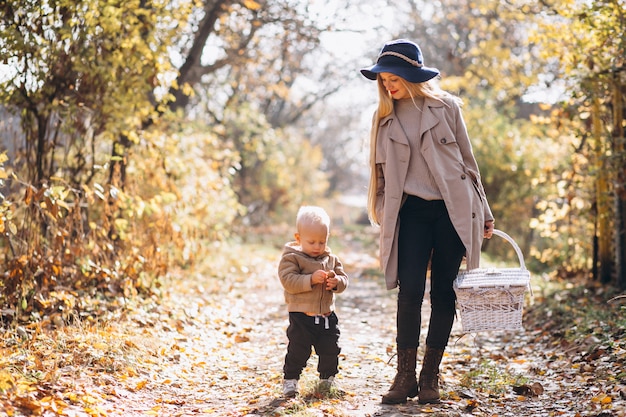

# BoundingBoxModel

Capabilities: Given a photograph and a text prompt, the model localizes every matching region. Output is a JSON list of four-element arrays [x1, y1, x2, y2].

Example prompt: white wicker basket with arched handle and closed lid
[[454, 229, 530, 333]]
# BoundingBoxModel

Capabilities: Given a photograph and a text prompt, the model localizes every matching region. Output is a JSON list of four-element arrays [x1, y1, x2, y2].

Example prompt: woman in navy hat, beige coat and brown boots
[[361, 39, 494, 404]]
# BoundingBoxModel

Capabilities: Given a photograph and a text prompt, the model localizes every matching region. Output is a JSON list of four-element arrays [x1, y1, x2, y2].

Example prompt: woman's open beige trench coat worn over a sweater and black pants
[[376, 97, 493, 290]]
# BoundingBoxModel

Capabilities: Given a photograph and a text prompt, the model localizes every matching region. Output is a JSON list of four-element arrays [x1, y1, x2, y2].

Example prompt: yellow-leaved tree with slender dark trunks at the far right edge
[[534, 0, 626, 288]]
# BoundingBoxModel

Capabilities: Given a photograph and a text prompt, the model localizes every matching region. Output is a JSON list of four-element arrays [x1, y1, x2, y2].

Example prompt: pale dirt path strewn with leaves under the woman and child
[[81, 237, 626, 417]]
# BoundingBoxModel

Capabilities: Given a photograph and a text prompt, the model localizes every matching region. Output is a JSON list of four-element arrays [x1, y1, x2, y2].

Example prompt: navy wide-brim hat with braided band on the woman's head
[[361, 39, 439, 83]]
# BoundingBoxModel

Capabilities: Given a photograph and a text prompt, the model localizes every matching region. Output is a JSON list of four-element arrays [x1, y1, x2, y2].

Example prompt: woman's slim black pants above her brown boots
[[396, 196, 465, 349]]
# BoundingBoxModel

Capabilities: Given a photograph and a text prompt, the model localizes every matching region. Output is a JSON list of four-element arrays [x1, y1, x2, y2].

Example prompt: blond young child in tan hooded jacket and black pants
[[278, 206, 348, 397]]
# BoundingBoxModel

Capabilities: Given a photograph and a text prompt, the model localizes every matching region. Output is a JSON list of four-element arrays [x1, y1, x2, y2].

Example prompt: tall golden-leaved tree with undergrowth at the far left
[[0, 0, 197, 314]]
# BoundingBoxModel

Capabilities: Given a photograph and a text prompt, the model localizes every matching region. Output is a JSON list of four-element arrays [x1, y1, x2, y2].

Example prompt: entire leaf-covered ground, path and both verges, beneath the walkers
[[0, 226, 626, 417]]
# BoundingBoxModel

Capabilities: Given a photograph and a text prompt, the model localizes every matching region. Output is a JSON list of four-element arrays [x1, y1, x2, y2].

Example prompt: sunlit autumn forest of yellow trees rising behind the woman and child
[[0, 0, 626, 360]]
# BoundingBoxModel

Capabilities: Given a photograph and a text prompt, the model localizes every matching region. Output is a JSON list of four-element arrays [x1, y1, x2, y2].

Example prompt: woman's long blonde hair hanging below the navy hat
[[367, 74, 463, 225]]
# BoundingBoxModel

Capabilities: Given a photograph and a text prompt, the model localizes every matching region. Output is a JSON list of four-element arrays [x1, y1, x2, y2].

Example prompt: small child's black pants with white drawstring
[[283, 312, 341, 379]]
